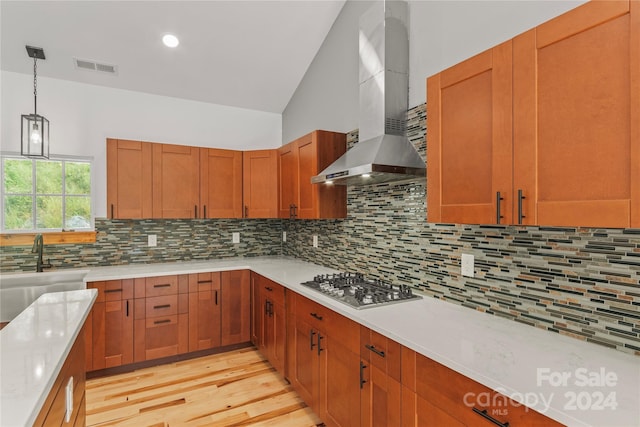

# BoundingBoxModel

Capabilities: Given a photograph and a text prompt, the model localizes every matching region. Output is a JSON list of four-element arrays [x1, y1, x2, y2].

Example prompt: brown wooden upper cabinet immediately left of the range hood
[[278, 130, 347, 219]]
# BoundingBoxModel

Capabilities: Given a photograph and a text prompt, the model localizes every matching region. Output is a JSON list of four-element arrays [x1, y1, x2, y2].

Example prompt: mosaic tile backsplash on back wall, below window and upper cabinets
[[0, 218, 282, 272]]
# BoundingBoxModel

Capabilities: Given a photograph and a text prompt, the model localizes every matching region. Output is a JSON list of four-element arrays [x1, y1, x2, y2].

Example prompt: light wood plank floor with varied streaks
[[86, 348, 320, 427]]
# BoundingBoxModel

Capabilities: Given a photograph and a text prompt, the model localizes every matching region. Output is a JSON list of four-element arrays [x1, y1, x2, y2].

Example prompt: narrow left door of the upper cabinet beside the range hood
[[278, 142, 299, 218]]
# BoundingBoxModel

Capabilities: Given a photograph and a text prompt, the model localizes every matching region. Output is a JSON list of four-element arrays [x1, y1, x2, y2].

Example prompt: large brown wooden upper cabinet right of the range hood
[[427, 0, 640, 227]]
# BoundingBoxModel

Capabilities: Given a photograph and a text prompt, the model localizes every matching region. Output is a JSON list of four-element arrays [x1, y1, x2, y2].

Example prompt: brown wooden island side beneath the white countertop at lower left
[[33, 333, 86, 427]]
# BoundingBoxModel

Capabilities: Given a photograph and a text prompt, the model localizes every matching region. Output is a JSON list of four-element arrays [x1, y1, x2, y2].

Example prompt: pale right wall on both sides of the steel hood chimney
[[282, 0, 584, 143]]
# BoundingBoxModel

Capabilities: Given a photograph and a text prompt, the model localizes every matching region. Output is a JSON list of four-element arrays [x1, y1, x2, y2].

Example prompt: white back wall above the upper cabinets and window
[[0, 71, 282, 217]]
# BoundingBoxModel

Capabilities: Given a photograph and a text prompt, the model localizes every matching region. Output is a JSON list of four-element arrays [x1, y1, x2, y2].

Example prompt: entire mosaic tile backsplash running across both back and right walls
[[0, 105, 640, 356]]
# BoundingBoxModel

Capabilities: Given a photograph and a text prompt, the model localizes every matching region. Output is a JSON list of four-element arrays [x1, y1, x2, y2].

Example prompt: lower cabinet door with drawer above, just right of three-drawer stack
[[189, 273, 221, 351]]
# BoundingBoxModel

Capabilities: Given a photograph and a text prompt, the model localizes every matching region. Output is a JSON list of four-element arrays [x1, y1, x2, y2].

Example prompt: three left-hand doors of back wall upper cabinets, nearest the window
[[107, 139, 244, 219]]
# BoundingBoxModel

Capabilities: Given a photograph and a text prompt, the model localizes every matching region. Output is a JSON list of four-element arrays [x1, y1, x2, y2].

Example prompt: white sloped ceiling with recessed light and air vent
[[0, 0, 345, 113]]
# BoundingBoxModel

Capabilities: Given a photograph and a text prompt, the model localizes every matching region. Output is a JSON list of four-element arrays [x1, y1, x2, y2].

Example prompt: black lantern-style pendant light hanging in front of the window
[[20, 46, 49, 159]]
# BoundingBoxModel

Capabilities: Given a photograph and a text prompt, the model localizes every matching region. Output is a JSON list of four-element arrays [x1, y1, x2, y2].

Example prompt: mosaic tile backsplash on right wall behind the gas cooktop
[[283, 105, 640, 356]]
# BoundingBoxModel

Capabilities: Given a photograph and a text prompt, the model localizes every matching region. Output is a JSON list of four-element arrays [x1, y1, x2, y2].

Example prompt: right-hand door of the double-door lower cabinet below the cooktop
[[318, 332, 362, 427]]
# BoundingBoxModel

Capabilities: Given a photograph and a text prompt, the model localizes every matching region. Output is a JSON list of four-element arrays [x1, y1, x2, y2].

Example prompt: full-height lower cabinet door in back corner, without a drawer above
[[221, 270, 251, 345]]
